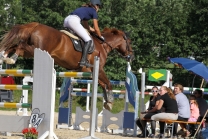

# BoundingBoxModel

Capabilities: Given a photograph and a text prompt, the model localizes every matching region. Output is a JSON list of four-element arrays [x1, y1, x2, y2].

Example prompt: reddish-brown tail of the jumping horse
[[0, 22, 39, 52]]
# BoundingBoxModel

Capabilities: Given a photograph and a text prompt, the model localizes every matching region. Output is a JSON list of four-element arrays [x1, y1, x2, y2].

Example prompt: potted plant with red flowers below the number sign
[[22, 127, 38, 139]]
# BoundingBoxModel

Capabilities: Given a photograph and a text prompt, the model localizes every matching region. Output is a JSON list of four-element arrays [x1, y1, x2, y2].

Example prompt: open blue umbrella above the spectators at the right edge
[[169, 58, 208, 82]]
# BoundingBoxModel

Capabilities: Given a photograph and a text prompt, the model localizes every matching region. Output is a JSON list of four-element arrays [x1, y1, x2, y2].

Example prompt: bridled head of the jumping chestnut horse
[[104, 29, 134, 62]]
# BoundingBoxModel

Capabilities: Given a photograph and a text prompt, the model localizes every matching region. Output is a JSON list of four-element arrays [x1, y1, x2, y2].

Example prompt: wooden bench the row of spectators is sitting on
[[142, 118, 201, 138]]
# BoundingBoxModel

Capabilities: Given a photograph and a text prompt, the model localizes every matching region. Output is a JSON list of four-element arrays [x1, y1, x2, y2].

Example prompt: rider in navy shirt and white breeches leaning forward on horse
[[64, 0, 104, 67]]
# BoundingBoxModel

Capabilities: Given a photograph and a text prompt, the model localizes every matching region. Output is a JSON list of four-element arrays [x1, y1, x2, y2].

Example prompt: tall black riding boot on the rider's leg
[[80, 40, 93, 67]]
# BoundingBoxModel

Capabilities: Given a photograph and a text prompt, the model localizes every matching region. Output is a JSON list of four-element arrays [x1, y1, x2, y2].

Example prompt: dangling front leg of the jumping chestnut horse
[[98, 70, 114, 110]]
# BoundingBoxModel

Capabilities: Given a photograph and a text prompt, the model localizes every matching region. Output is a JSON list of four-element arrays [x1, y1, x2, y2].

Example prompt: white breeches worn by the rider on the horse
[[64, 15, 92, 42]]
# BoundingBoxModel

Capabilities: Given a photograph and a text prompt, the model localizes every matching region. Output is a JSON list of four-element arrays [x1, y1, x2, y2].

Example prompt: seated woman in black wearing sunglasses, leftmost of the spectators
[[136, 86, 160, 138]]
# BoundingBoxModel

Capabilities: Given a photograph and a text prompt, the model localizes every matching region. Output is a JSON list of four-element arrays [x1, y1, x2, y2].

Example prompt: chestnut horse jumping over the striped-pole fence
[[0, 22, 134, 110]]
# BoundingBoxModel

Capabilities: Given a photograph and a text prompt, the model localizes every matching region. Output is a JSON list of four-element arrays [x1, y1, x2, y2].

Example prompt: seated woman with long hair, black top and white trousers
[[151, 86, 178, 138]]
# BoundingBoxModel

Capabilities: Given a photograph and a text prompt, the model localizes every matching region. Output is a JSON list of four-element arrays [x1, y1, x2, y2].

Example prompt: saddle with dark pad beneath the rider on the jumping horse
[[60, 28, 95, 54]]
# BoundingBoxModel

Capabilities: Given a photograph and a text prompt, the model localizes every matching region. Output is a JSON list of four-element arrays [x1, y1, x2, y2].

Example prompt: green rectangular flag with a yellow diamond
[[148, 69, 167, 81]]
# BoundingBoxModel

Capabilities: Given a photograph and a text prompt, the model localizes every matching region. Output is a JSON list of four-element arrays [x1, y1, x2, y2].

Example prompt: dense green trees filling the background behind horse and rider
[[0, 0, 208, 86]]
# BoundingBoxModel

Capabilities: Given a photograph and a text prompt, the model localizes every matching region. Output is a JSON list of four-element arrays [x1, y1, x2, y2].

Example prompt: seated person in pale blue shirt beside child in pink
[[173, 84, 190, 137]]
